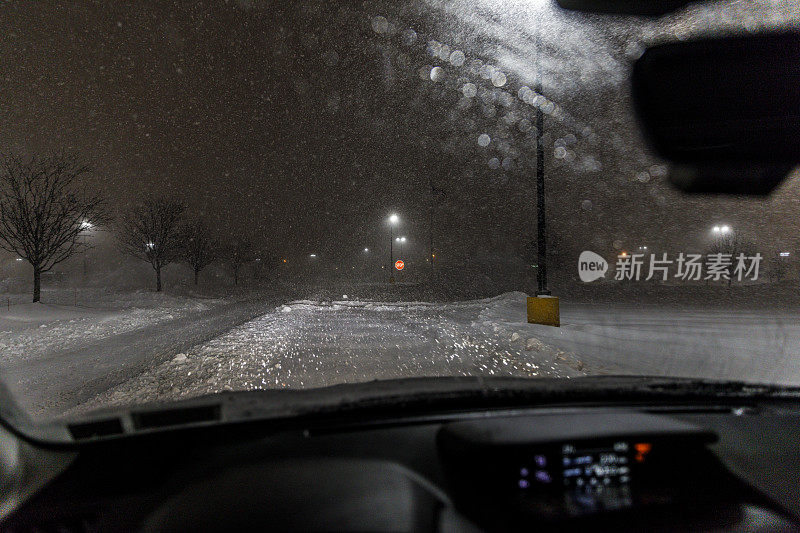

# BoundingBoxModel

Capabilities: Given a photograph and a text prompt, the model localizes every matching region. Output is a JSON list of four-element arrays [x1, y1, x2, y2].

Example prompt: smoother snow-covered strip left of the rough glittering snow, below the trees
[[0, 291, 282, 418]]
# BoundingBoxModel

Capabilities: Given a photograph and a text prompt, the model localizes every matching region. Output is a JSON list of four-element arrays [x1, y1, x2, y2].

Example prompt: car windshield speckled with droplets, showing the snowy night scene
[[0, 0, 800, 420]]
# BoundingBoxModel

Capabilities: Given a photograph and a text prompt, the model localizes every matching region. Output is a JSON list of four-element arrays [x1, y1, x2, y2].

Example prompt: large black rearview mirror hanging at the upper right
[[632, 33, 800, 194]]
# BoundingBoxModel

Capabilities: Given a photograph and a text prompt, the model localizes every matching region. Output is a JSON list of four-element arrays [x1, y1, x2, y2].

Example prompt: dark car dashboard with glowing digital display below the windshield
[[3, 403, 800, 531]]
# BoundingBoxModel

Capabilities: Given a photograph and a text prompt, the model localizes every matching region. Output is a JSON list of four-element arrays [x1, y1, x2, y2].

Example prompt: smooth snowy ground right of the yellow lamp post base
[[520, 302, 800, 386]]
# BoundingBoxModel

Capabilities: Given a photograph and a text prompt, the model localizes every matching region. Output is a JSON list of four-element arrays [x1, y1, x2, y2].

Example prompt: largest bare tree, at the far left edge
[[0, 154, 108, 302]]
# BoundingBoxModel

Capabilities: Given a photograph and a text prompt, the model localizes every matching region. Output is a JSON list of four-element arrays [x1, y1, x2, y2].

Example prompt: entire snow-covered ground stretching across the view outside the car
[[0, 287, 800, 424]]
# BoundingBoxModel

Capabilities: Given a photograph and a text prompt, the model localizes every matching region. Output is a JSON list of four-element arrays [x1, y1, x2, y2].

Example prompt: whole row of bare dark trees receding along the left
[[0, 154, 275, 302]]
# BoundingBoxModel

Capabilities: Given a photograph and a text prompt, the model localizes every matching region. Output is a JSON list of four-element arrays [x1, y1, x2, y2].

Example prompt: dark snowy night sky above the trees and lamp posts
[[0, 0, 800, 272]]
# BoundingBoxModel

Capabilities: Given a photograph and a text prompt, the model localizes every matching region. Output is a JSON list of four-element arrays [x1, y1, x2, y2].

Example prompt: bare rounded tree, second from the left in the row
[[119, 198, 186, 292]]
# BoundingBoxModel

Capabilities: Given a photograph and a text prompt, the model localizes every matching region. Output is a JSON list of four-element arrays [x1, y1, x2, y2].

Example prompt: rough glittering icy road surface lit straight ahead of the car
[[73, 293, 589, 414]]
